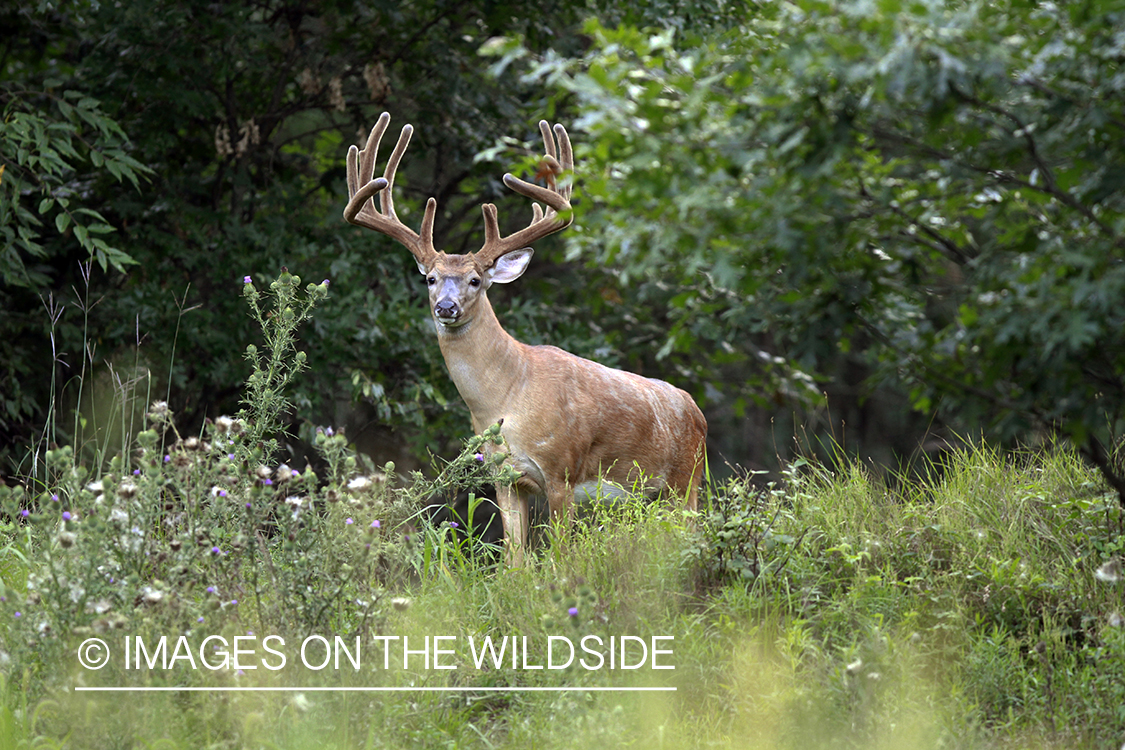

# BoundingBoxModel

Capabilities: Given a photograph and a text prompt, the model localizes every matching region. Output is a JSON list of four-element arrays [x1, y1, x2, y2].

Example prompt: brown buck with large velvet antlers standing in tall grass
[[344, 112, 707, 567]]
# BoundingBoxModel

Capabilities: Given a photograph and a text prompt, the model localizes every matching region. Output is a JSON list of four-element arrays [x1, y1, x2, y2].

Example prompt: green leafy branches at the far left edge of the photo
[[0, 3, 149, 452]]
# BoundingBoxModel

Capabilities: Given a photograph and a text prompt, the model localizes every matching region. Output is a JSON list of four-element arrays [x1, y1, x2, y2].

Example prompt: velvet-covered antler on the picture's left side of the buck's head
[[344, 112, 438, 265]]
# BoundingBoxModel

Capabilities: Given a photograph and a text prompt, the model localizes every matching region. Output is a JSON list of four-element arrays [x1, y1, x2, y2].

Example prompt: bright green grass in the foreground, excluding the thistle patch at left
[[0, 448, 1125, 748]]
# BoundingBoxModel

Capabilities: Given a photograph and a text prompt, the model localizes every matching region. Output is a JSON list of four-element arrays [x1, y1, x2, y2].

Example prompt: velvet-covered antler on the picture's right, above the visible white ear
[[475, 120, 574, 265]]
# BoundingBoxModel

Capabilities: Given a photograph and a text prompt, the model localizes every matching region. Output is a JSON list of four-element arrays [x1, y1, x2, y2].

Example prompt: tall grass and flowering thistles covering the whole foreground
[[0, 278, 1125, 749]]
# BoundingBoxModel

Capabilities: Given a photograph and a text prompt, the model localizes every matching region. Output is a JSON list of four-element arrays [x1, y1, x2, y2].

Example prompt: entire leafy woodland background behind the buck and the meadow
[[0, 0, 1125, 497]]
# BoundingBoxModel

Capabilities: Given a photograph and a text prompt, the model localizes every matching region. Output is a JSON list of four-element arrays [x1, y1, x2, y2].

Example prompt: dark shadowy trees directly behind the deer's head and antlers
[[0, 0, 751, 472]]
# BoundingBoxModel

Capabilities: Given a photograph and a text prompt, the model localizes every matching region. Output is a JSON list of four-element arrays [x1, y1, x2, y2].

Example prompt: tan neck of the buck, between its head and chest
[[438, 297, 524, 422]]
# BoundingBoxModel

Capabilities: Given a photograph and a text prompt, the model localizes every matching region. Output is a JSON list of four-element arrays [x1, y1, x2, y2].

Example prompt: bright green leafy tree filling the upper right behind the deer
[[495, 0, 1125, 504]]
